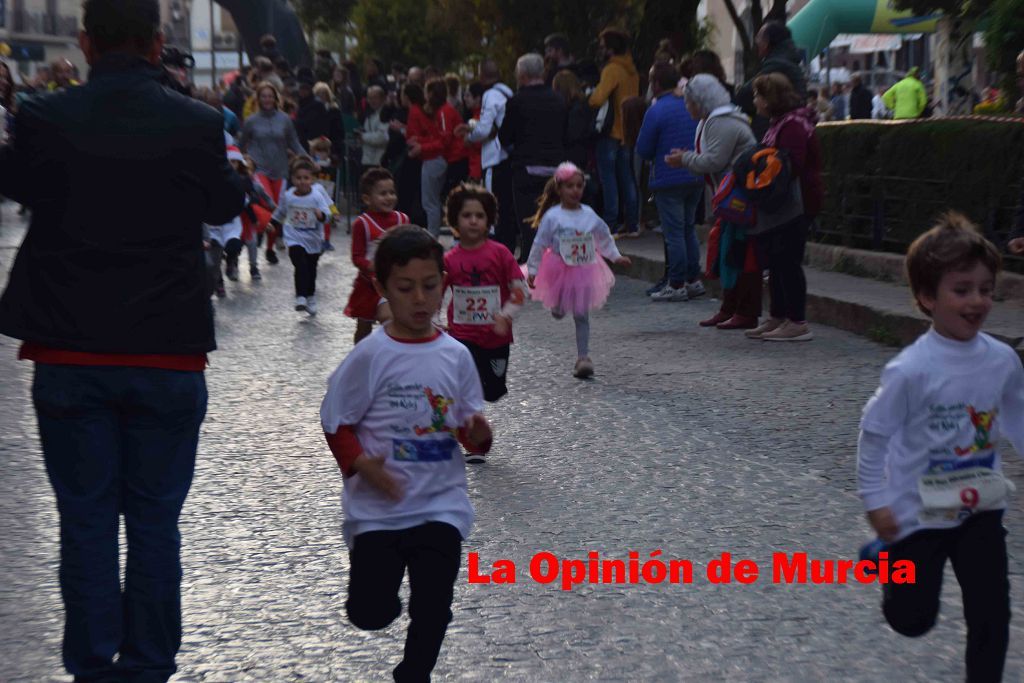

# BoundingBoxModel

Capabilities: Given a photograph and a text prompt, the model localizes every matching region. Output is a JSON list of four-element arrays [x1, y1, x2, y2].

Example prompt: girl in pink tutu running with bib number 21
[[526, 162, 630, 379]]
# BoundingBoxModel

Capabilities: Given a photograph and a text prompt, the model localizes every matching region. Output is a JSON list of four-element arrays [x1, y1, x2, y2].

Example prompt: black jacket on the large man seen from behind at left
[[0, 54, 244, 354]]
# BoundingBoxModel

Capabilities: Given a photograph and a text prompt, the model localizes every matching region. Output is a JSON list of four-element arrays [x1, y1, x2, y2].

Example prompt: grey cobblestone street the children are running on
[[0, 210, 1024, 683]]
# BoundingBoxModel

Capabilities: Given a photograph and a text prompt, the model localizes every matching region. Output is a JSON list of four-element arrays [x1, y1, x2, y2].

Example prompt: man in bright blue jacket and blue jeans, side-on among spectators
[[637, 63, 705, 301]]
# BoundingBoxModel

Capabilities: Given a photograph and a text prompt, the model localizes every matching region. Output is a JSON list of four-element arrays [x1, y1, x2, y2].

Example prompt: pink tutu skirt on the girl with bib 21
[[531, 249, 615, 315]]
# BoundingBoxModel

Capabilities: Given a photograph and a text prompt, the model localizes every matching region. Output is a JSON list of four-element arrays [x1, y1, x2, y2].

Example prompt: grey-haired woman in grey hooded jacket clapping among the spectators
[[666, 74, 762, 330]]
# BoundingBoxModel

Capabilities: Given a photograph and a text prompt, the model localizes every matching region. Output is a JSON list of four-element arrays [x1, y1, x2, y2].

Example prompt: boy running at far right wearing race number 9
[[857, 213, 1024, 681]]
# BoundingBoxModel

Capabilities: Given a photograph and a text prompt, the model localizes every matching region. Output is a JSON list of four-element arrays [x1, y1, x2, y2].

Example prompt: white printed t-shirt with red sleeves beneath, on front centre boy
[[321, 326, 483, 546]]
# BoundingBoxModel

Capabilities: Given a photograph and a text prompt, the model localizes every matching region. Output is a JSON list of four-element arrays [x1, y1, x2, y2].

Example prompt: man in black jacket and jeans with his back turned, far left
[[0, 0, 243, 681]]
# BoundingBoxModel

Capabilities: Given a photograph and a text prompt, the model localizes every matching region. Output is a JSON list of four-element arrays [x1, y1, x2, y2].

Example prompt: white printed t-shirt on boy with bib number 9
[[858, 330, 1024, 539]]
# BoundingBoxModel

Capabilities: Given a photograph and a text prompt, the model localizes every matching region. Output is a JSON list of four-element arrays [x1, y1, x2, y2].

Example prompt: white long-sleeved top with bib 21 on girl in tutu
[[526, 204, 622, 275]]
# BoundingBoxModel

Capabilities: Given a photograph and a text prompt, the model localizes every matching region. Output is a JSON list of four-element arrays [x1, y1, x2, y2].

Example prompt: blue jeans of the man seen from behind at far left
[[32, 364, 207, 682]]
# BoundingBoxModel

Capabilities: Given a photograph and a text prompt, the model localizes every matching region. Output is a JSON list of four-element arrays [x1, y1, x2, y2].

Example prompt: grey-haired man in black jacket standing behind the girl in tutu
[[498, 53, 566, 263]]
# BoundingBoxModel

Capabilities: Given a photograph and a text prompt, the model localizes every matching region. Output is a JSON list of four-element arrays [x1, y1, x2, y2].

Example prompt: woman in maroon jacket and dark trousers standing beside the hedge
[[745, 74, 824, 341]]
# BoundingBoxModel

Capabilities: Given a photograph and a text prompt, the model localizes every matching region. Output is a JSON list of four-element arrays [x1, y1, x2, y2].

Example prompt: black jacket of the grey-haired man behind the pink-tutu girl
[[498, 84, 566, 167]]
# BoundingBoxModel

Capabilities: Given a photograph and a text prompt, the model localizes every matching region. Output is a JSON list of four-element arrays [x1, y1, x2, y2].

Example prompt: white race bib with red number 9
[[918, 467, 1013, 522]]
